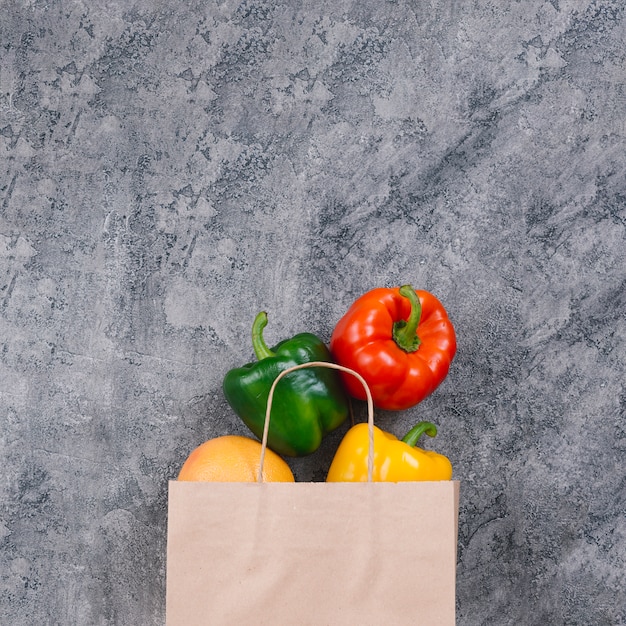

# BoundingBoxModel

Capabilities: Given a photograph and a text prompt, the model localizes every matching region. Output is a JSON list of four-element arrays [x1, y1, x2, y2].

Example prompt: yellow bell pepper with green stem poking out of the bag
[[326, 422, 452, 482]]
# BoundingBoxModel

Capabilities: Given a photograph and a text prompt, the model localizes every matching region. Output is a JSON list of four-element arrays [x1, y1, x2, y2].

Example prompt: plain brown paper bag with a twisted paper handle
[[166, 360, 459, 626]]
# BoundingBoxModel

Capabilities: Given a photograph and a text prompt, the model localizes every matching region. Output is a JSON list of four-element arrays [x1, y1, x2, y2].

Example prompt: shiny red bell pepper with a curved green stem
[[330, 285, 456, 411]]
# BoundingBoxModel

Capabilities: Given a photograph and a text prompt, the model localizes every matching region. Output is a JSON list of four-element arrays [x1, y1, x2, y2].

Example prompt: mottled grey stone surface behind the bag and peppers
[[0, 0, 626, 626]]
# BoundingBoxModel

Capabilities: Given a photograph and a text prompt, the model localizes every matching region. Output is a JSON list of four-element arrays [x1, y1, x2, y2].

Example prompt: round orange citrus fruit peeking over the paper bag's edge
[[178, 435, 295, 483]]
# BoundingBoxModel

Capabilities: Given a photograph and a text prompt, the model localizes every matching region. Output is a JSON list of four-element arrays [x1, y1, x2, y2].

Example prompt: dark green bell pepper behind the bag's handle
[[223, 311, 350, 456]]
